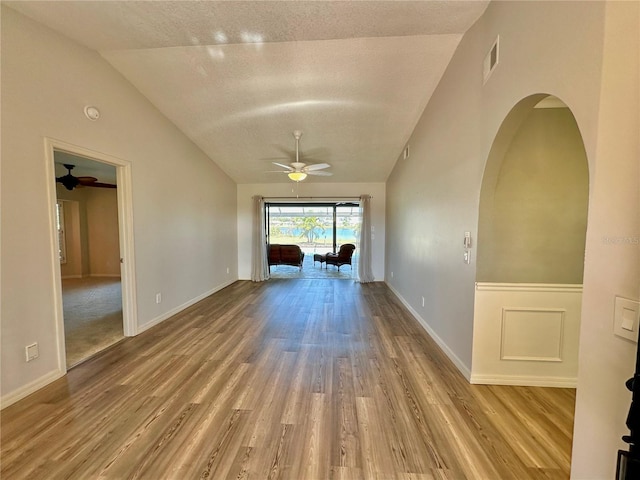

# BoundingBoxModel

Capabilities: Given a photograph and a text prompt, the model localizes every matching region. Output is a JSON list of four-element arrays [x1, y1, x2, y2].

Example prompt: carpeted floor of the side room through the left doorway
[[62, 277, 124, 368]]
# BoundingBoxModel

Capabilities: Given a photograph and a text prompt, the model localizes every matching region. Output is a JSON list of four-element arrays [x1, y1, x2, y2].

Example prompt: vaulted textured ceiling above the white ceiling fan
[[4, 0, 488, 183]]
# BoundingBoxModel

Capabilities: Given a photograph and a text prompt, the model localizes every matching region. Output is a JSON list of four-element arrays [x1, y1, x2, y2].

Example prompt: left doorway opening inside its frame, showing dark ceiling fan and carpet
[[53, 150, 124, 368]]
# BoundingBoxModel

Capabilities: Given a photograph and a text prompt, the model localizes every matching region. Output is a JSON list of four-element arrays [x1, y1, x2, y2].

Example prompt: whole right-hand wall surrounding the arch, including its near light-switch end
[[386, 2, 640, 480]]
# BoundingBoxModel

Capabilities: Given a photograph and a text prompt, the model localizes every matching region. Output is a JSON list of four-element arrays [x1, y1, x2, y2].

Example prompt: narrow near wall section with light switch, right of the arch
[[572, 2, 640, 480]]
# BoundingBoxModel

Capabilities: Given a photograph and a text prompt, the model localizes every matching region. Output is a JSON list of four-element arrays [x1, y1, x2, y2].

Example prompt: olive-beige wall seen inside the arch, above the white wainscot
[[476, 108, 589, 284]]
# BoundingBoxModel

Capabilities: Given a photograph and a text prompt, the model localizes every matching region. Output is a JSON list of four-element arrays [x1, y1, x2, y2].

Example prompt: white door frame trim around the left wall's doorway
[[44, 137, 138, 373]]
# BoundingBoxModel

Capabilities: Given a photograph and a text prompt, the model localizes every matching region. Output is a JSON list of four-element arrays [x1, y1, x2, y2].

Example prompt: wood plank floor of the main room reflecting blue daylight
[[0, 279, 574, 480]]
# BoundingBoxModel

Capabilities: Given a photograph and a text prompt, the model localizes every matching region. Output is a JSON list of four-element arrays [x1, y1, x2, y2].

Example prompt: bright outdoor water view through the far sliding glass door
[[266, 203, 362, 255]]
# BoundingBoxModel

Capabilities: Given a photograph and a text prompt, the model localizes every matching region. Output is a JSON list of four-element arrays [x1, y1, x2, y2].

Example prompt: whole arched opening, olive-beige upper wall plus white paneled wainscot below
[[472, 94, 589, 386]]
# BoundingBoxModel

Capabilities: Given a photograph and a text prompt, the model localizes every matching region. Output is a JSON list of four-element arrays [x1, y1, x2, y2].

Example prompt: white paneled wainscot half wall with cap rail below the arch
[[471, 282, 582, 387]]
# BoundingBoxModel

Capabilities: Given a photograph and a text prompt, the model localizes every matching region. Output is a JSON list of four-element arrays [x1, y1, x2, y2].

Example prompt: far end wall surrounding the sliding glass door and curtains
[[238, 182, 385, 281]]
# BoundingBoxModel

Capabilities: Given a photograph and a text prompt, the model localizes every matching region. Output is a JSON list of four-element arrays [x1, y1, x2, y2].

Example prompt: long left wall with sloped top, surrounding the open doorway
[[1, 7, 237, 404]]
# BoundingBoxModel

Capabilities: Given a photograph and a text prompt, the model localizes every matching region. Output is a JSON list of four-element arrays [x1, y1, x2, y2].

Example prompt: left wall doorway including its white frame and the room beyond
[[45, 139, 137, 371]]
